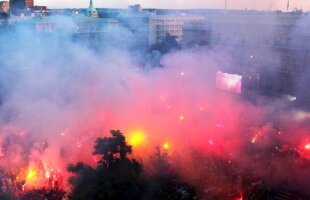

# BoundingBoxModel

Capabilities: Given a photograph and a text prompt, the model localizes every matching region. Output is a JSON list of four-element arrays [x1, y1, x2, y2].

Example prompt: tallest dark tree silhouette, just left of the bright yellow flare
[[67, 131, 143, 200]]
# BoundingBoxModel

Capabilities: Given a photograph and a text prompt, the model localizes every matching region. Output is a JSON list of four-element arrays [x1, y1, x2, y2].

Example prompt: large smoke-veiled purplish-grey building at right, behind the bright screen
[[191, 10, 310, 102]]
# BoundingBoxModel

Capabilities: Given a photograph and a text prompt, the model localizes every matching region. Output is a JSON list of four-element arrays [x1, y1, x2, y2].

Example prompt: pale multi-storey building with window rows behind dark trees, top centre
[[149, 14, 205, 45]]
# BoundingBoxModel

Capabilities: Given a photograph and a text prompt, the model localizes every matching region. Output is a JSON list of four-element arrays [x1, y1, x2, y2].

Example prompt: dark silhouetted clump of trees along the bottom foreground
[[14, 131, 198, 200]]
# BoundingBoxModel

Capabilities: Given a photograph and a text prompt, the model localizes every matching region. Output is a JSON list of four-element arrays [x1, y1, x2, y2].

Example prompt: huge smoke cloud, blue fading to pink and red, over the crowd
[[0, 14, 309, 196]]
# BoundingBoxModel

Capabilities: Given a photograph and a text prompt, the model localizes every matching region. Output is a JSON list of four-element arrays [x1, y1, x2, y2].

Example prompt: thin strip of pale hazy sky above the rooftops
[[35, 0, 310, 10]]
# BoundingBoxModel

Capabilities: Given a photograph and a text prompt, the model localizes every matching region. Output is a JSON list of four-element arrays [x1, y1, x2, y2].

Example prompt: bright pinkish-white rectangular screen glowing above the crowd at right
[[216, 71, 242, 94]]
